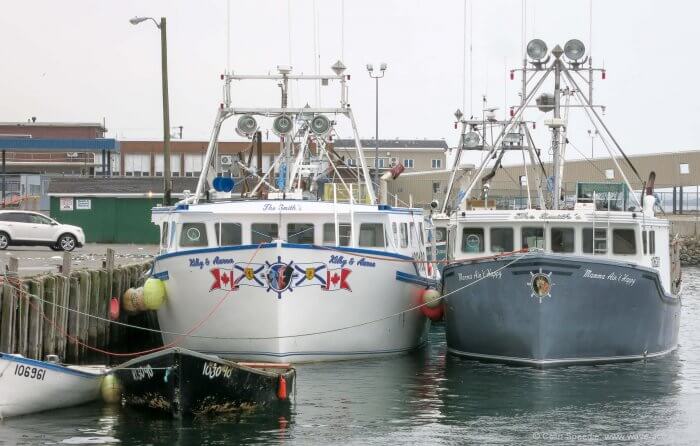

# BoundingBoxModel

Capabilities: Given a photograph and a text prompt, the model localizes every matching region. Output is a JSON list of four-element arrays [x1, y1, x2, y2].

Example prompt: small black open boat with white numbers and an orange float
[[112, 348, 296, 417]]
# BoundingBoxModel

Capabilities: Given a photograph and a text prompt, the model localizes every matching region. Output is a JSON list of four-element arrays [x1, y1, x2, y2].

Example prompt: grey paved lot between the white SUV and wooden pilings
[[0, 243, 158, 276]]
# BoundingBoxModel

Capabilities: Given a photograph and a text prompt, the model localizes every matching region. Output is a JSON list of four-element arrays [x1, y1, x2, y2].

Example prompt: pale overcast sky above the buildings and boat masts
[[0, 0, 700, 166]]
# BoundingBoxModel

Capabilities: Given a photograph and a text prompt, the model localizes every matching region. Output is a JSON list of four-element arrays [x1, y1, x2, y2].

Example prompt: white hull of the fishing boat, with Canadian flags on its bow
[[154, 243, 429, 362]]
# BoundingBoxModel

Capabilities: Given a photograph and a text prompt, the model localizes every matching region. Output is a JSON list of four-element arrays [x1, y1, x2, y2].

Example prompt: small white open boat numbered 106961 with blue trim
[[0, 353, 107, 418]]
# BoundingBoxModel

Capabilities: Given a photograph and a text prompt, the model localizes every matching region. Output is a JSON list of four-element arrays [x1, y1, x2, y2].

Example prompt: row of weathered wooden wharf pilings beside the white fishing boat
[[0, 253, 157, 364]]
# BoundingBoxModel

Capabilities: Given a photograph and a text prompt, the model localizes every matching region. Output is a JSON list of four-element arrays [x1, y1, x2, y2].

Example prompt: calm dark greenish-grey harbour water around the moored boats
[[0, 269, 700, 445]]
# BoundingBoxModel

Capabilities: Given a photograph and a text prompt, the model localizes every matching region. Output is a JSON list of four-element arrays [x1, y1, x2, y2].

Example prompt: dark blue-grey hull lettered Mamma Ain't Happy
[[443, 254, 681, 367]]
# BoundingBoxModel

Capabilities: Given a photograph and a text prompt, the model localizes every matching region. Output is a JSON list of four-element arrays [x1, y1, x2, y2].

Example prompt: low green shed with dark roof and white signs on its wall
[[48, 177, 197, 244]]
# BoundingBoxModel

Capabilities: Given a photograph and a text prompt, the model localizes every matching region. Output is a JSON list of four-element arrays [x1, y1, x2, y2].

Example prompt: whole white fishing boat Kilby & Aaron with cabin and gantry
[[152, 62, 438, 362]]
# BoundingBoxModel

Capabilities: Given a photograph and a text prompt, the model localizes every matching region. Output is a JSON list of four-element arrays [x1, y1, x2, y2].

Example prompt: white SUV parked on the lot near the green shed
[[0, 211, 85, 251]]
